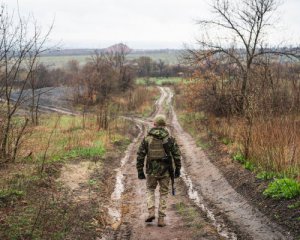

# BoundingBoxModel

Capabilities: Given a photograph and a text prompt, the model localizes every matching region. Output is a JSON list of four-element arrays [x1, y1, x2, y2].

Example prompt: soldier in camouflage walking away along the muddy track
[[136, 115, 181, 227]]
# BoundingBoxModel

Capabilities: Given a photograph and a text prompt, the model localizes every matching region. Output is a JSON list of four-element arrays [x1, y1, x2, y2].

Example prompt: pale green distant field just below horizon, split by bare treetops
[[40, 51, 179, 67]]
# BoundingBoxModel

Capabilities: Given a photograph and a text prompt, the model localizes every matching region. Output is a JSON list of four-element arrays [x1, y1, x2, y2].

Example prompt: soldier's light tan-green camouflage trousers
[[147, 175, 170, 217]]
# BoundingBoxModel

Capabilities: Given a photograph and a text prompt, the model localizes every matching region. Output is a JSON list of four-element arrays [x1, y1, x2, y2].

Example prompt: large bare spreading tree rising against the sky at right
[[185, 0, 299, 112]]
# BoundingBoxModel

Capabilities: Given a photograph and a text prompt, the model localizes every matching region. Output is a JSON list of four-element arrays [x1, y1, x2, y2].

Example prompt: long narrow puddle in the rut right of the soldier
[[181, 167, 237, 240]]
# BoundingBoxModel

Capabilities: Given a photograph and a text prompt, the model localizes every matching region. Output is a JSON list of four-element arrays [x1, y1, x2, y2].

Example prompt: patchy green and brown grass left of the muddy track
[[0, 114, 131, 239]]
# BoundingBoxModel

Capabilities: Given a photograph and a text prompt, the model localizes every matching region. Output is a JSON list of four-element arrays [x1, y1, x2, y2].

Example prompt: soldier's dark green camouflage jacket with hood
[[136, 127, 181, 177]]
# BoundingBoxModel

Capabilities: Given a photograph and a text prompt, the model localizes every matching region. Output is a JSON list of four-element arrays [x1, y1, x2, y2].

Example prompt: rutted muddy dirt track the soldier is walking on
[[102, 87, 289, 240]]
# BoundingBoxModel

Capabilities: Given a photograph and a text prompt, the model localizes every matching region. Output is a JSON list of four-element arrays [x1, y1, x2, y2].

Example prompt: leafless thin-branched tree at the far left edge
[[0, 6, 52, 162]]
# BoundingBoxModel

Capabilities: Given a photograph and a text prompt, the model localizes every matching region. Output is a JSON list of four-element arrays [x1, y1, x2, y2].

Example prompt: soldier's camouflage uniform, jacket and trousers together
[[136, 127, 181, 218]]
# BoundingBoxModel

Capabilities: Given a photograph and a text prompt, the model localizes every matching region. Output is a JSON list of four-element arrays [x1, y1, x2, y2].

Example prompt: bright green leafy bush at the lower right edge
[[263, 178, 300, 199]]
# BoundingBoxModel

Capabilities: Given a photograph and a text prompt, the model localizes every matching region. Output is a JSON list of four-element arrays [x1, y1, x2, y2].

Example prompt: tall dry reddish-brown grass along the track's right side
[[175, 83, 300, 181]]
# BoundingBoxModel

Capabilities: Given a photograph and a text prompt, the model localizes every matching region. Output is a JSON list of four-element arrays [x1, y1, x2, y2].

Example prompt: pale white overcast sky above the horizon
[[4, 0, 300, 49]]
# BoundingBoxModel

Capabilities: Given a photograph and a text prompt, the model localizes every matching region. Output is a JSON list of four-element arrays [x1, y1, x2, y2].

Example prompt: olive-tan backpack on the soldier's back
[[147, 136, 168, 160]]
